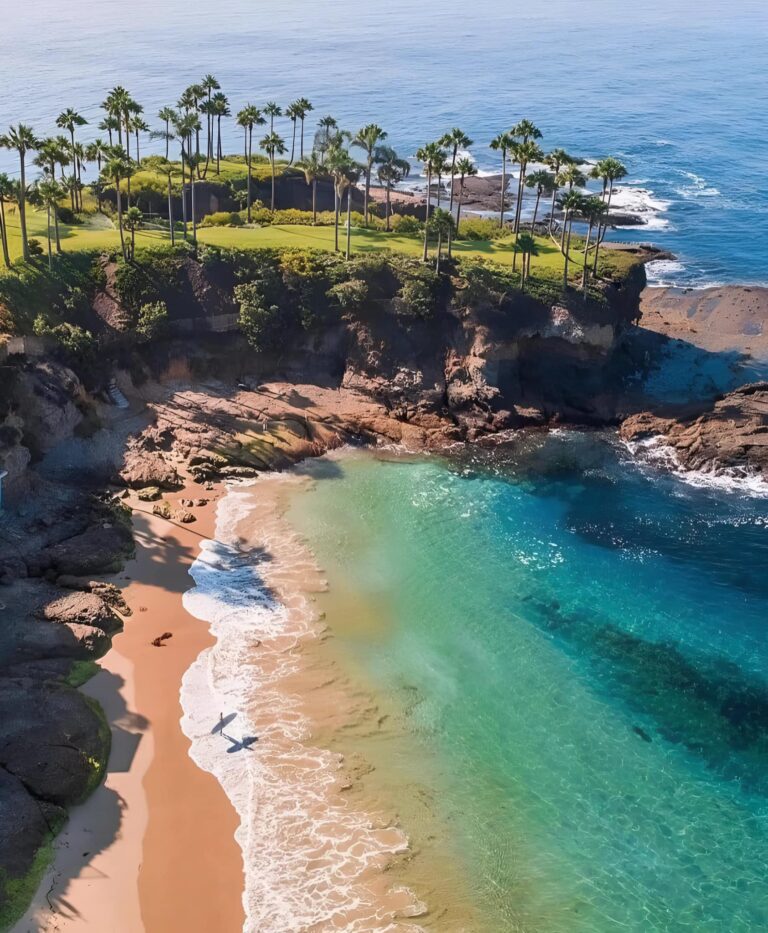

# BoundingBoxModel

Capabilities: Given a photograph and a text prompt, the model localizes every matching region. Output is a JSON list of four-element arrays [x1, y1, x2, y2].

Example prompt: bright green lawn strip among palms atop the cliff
[[0, 200, 634, 276]]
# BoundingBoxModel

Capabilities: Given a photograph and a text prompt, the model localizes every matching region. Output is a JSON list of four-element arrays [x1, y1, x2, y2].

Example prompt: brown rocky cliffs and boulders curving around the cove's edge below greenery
[[0, 258, 768, 916]]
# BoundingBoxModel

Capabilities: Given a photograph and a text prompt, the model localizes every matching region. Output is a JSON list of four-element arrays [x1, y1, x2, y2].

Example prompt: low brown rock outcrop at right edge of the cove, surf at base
[[620, 382, 768, 480]]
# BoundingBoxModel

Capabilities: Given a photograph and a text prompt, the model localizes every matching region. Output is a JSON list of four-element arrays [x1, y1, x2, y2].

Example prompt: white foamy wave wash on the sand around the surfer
[[181, 476, 421, 933]]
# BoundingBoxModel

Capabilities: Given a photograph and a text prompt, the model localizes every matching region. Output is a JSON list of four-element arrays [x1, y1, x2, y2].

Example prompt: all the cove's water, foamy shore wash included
[[181, 440, 768, 933]]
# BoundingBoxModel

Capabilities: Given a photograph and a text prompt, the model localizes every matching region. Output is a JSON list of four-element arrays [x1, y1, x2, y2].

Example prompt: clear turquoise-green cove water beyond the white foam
[[289, 433, 768, 933]]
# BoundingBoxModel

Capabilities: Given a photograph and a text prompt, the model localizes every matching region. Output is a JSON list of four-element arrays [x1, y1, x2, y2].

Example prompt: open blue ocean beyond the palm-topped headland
[[0, 0, 768, 285]]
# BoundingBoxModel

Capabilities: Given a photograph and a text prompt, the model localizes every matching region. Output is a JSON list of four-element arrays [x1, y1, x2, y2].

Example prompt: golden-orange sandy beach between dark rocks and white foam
[[14, 486, 243, 933]]
